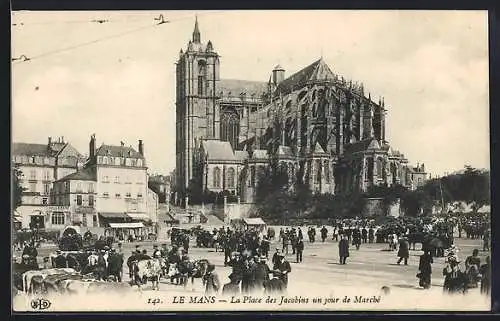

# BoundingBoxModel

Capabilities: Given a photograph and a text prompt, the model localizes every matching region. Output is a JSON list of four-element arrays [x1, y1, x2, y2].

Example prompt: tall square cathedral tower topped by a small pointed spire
[[176, 18, 219, 193]]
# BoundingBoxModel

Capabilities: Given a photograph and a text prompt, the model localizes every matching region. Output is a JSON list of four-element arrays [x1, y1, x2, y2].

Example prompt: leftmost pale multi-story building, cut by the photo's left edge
[[12, 137, 84, 228]]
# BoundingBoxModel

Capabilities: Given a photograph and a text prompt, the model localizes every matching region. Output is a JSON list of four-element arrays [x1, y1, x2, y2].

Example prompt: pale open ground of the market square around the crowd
[[12, 232, 489, 310]]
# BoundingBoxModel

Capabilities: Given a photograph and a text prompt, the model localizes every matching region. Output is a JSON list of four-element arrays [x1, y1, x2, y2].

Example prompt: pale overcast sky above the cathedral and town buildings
[[12, 11, 489, 174]]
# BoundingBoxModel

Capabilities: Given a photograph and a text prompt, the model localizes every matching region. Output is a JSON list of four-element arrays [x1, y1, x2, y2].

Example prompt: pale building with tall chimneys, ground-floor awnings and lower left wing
[[47, 135, 158, 234]]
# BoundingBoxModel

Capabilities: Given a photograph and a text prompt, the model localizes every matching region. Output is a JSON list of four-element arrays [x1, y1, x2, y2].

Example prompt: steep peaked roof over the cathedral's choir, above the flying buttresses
[[276, 58, 335, 93]]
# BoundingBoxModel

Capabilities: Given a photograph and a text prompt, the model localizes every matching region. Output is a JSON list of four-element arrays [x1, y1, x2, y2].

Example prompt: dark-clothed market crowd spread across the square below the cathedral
[[12, 210, 491, 295]]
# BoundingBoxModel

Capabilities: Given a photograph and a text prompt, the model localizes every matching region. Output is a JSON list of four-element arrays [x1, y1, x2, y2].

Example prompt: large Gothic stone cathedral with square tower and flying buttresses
[[175, 20, 427, 203]]
